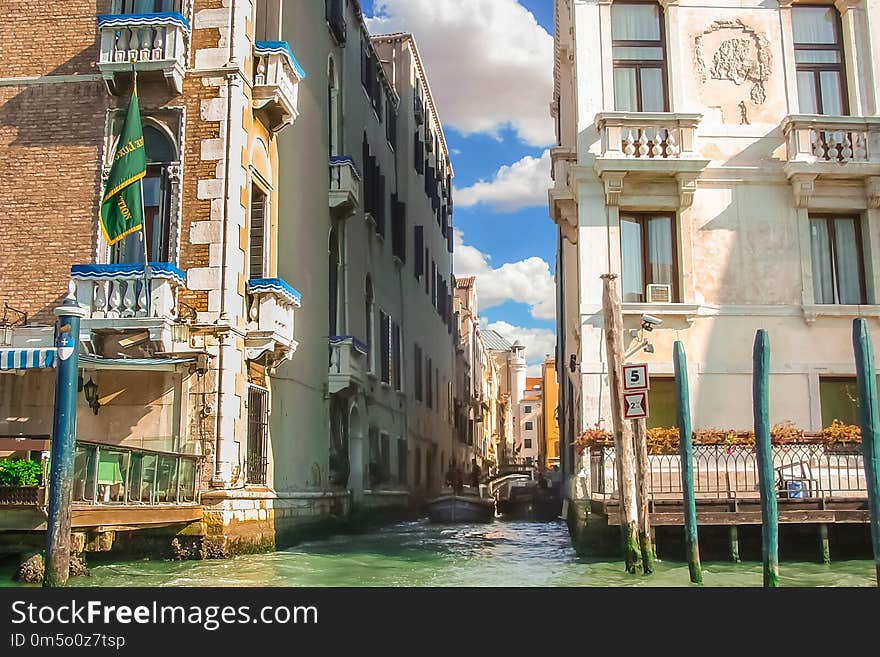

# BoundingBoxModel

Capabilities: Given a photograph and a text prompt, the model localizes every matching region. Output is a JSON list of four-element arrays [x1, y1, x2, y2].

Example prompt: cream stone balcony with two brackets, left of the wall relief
[[594, 112, 709, 207]]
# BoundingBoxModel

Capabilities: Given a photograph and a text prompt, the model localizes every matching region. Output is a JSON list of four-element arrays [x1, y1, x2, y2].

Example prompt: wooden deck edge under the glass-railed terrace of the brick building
[[0, 504, 202, 532]]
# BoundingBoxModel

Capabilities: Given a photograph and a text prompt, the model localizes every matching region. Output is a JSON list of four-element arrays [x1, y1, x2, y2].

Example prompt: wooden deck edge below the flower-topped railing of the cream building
[[590, 496, 870, 527]]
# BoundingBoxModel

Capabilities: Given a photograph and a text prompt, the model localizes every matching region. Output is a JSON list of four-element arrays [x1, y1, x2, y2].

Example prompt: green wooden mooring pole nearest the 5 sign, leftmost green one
[[672, 340, 703, 584]]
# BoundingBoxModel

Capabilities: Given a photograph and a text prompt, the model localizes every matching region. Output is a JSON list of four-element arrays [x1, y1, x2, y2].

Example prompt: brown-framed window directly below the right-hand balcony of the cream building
[[810, 216, 866, 304]]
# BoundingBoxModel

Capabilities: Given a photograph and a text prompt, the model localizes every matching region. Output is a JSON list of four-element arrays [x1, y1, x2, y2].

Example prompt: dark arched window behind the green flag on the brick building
[[110, 123, 178, 264]]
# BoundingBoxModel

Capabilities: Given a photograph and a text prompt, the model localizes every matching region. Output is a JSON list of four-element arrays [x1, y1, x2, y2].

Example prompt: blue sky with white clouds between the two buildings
[[361, 0, 556, 372]]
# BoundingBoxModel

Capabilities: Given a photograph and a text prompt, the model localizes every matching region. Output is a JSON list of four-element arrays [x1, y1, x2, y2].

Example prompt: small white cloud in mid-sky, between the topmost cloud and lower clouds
[[455, 150, 550, 212]]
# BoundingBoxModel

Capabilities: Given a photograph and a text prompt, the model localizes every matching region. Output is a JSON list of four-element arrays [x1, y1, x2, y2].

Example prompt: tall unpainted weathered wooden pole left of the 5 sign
[[602, 274, 642, 573]]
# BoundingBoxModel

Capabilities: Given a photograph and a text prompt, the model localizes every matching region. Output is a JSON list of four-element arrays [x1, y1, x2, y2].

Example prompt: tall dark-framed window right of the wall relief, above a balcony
[[791, 5, 849, 115]]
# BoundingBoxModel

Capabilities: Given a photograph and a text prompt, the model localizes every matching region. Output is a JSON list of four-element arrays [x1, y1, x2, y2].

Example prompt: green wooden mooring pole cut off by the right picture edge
[[853, 318, 880, 586]]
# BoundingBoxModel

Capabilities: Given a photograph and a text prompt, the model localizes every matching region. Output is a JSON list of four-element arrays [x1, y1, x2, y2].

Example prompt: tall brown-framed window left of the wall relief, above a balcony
[[611, 2, 667, 112]]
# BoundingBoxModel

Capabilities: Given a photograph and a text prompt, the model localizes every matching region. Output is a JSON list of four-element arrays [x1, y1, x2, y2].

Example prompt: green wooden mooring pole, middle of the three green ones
[[752, 329, 779, 587]]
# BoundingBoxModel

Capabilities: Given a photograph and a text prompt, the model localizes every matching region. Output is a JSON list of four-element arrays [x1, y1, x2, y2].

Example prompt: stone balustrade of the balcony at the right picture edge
[[782, 114, 880, 164]]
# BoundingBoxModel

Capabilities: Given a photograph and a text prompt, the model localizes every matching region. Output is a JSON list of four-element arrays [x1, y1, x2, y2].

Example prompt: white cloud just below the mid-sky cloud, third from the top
[[455, 230, 556, 321]]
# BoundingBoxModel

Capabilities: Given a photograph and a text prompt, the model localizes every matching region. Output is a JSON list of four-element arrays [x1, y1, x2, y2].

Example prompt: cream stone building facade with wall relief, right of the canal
[[549, 0, 880, 492]]
